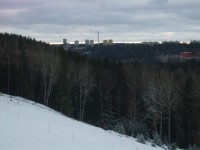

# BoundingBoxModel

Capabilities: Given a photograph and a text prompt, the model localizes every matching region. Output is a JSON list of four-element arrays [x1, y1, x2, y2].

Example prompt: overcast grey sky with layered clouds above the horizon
[[0, 0, 200, 43]]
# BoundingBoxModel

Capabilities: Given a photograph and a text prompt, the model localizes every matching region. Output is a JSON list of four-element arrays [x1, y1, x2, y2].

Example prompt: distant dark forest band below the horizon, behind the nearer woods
[[85, 43, 200, 63]]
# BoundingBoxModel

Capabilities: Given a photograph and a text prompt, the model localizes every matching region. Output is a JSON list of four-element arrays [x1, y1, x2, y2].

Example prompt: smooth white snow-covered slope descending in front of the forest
[[0, 94, 162, 150]]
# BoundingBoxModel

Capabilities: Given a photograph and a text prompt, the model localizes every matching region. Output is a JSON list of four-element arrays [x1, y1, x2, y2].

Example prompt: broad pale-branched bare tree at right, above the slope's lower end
[[143, 72, 180, 144]]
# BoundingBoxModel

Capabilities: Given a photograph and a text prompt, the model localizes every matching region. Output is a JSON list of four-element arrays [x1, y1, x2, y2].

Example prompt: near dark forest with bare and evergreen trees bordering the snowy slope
[[0, 33, 200, 148]]
